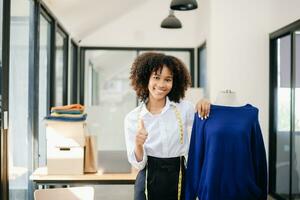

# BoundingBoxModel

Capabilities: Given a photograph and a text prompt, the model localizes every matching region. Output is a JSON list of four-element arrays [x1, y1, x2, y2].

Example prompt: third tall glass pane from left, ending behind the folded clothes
[[54, 32, 66, 106]]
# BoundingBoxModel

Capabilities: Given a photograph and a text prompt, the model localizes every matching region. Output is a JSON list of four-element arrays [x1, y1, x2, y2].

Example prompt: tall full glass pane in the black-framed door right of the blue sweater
[[276, 36, 291, 197]]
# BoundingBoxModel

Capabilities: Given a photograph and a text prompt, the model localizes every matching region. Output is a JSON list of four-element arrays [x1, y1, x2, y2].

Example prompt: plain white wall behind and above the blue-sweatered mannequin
[[207, 0, 300, 155]]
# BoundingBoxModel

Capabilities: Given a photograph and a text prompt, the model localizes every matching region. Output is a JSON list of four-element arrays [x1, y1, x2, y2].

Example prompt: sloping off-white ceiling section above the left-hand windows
[[44, 0, 149, 40]]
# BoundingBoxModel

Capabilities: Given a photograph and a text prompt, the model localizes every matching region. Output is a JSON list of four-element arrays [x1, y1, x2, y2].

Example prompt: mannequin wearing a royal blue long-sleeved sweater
[[185, 90, 268, 200]]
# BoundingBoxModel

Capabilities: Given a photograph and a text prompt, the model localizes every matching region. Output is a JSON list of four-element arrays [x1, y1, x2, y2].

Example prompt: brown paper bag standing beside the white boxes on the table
[[84, 136, 98, 173]]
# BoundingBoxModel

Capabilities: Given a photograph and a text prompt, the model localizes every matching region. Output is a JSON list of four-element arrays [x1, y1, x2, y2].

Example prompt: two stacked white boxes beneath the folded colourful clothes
[[46, 104, 86, 175]]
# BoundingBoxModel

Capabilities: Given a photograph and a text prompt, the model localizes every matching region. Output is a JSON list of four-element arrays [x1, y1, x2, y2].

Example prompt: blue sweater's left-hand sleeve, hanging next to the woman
[[185, 113, 205, 200]]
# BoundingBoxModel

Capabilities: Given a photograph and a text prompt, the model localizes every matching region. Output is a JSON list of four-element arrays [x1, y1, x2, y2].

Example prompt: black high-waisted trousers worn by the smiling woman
[[134, 156, 185, 200]]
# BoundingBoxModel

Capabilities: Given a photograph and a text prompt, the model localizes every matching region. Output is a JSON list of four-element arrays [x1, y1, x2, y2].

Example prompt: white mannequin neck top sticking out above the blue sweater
[[215, 89, 240, 106]]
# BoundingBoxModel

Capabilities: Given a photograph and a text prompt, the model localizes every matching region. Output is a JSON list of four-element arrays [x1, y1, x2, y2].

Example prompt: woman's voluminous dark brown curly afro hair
[[129, 52, 191, 103]]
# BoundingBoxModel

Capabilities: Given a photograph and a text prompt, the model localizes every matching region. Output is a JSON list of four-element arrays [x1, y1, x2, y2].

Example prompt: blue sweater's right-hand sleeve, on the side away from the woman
[[251, 117, 268, 200]]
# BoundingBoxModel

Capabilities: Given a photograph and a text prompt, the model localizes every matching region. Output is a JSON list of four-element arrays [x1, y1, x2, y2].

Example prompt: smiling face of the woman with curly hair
[[148, 66, 173, 100]]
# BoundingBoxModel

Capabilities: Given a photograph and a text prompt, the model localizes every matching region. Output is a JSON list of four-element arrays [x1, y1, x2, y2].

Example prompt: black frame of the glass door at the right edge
[[269, 20, 300, 200]]
